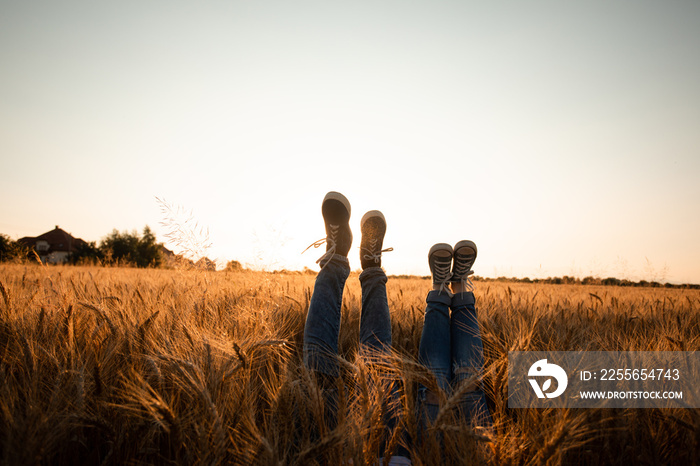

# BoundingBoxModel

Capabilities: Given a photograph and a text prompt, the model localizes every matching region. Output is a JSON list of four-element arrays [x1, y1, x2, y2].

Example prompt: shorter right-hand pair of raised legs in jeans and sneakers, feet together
[[418, 240, 491, 426]]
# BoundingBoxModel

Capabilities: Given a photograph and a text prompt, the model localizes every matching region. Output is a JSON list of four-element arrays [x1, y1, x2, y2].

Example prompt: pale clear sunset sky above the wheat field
[[0, 0, 700, 283]]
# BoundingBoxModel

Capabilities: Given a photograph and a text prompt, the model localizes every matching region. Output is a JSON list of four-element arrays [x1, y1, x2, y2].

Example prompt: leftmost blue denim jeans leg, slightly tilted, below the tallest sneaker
[[303, 254, 350, 377]]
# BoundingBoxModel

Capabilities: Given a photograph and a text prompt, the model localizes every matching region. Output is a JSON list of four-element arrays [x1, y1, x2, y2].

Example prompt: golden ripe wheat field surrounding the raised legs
[[0, 264, 700, 465]]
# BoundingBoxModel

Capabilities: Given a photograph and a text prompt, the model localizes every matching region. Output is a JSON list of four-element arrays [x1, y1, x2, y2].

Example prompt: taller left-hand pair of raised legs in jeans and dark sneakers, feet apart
[[303, 192, 403, 457]]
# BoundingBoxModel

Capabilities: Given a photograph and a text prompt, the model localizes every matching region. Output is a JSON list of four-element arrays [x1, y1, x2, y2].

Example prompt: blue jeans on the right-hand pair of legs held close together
[[418, 290, 492, 426]]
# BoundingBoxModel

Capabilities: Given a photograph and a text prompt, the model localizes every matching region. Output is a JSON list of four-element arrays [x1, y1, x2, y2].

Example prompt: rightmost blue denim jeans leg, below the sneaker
[[450, 291, 492, 425]]
